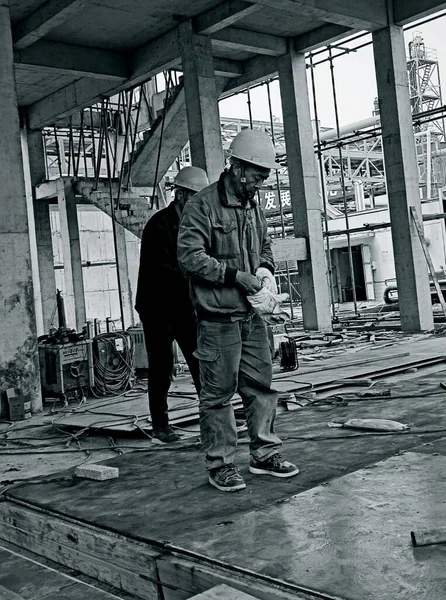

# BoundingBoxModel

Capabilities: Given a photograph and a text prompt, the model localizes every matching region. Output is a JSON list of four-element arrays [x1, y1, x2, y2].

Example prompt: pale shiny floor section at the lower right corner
[[176, 452, 446, 600]]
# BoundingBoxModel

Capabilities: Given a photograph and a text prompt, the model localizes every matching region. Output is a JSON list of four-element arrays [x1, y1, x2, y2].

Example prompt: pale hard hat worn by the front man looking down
[[228, 129, 281, 169]]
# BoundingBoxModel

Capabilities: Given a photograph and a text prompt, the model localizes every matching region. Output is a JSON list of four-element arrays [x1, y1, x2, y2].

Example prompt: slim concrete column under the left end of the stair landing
[[57, 179, 87, 331]]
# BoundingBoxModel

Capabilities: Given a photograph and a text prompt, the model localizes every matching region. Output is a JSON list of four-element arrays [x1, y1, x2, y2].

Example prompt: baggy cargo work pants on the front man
[[196, 315, 282, 469]]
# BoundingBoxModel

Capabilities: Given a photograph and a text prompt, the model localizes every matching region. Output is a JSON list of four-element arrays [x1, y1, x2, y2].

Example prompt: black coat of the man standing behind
[[135, 202, 193, 319]]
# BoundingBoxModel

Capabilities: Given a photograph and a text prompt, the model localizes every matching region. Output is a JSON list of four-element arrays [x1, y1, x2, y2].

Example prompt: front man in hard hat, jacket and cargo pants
[[178, 130, 299, 492]]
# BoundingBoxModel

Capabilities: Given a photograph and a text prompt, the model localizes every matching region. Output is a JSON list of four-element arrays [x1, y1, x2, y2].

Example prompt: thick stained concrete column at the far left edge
[[0, 0, 42, 416]]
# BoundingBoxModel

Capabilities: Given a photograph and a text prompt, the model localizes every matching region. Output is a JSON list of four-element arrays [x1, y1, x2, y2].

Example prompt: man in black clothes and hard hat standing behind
[[135, 167, 209, 443]]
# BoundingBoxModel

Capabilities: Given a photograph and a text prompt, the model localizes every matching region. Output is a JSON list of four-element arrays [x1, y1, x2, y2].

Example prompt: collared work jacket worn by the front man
[[178, 173, 274, 318]]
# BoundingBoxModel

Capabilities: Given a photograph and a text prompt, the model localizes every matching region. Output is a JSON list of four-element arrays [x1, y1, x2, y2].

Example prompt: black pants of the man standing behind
[[141, 312, 200, 428]]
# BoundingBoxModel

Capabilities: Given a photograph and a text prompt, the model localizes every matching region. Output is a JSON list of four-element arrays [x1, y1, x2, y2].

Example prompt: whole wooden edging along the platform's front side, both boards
[[0, 500, 301, 600]]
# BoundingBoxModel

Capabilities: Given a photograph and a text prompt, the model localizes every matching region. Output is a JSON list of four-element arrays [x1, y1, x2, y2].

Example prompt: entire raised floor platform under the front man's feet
[[0, 337, 446, 600]]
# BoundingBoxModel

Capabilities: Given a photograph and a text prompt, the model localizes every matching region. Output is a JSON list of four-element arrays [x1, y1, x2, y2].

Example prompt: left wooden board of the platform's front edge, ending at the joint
[[0, 502, 158, 598]]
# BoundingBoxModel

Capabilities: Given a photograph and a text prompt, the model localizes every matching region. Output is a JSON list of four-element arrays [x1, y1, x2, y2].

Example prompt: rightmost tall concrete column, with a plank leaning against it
[[373, 26, 433, 331]]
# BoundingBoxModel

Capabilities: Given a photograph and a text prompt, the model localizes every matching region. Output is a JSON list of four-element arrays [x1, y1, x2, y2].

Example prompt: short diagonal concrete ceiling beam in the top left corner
[[12, 0, 90, 50]]
